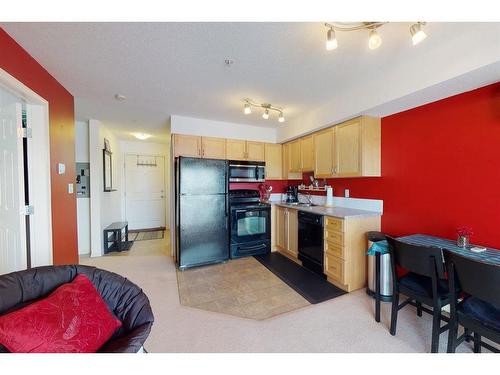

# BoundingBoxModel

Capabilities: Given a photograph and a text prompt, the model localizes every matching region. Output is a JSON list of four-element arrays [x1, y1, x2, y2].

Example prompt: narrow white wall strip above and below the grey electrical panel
[[75, 121, 92, 255]]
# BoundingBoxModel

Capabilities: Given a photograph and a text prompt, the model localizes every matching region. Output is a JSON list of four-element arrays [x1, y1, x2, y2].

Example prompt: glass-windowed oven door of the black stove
[[231, 205, 271, 244]]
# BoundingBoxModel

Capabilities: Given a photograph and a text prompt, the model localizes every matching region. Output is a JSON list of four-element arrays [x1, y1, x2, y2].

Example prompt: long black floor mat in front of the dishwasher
[[254, 252, 346, 304]]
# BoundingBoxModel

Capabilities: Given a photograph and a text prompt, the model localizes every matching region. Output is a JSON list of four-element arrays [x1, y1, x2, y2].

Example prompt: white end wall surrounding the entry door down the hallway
[[120, 137, 170, 228]]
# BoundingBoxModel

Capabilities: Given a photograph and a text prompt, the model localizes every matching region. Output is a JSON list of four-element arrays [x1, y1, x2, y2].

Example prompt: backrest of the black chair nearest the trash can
[[387, 236, 445, 279]]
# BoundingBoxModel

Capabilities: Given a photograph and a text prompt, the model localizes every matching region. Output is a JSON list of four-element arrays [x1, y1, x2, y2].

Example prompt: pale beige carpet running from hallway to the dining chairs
[[82, 232, 486, 352]]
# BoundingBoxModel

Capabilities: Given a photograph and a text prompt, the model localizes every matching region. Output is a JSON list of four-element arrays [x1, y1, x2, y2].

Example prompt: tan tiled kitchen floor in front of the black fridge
[[177, 257, 310, 320]]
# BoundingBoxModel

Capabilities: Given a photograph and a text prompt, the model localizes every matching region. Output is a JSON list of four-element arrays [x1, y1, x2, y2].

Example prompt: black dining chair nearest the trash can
[[387, 236, 450, 353]]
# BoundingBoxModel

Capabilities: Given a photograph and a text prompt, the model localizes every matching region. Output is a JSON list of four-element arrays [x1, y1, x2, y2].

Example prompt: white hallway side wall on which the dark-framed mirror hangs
[[89, 120, 123, 257]]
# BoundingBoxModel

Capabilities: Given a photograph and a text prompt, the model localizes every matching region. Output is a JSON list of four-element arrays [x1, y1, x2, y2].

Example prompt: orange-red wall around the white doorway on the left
[[0, 28, 78, 264]]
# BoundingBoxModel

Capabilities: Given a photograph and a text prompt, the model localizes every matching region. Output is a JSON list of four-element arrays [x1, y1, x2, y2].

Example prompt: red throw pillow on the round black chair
[[0, 275, 122, 353]]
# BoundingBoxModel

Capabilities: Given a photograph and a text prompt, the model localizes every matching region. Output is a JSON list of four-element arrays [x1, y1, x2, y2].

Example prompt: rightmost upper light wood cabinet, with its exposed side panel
[[334, 116, 381, 177]]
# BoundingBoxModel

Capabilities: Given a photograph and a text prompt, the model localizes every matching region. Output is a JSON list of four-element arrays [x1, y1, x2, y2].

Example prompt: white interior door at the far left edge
[[0, 87, 27, 274]]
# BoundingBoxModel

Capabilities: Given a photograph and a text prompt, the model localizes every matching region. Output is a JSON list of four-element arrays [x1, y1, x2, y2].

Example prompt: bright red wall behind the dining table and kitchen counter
[[322, 82, 500, 248]]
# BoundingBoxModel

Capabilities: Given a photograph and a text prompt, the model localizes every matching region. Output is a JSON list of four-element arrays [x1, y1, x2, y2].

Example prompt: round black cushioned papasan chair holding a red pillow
[[0, 265, 154, 353]]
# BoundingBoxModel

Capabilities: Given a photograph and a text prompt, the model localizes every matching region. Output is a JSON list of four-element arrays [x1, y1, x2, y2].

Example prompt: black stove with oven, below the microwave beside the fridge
[[229, 189, 271, 259]]
